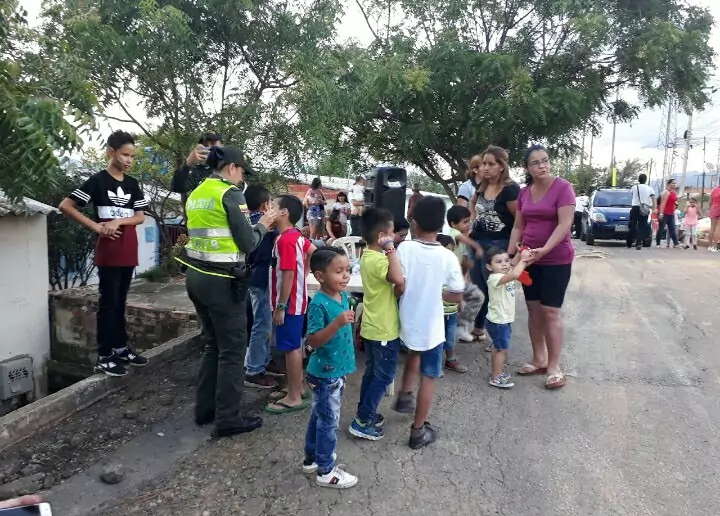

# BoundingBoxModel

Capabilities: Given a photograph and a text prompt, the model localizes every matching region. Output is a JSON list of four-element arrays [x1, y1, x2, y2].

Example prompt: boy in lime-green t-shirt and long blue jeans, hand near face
[[349, 208, 405, 441]]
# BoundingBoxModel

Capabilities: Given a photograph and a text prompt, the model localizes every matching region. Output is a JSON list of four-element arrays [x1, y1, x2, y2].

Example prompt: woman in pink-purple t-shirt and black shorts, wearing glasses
[[508, 145, 575, 389]]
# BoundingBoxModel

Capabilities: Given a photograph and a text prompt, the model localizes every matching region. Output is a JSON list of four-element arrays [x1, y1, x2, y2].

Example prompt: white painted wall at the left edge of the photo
[[0, 214, 50, 397]]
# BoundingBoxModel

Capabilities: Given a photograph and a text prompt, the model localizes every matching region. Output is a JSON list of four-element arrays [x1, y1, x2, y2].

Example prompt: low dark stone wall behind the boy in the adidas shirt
[[50, 288, 197, 369]]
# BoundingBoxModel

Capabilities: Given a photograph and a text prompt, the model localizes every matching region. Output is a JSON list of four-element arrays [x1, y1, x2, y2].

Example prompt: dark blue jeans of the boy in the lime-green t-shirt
[[357, 338, 400, 423]]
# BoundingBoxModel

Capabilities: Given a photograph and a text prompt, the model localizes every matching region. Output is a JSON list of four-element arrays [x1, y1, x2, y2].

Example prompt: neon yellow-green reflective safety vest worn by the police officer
[[185, 177, 244, 265]]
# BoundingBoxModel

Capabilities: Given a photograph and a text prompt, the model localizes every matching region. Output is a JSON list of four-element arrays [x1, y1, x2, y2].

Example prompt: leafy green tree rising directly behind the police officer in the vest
[[44, 0, 340, 171]]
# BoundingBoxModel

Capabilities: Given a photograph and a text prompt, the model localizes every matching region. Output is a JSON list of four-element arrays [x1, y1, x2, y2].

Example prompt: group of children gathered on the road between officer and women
[[240, 188, 529, 488]]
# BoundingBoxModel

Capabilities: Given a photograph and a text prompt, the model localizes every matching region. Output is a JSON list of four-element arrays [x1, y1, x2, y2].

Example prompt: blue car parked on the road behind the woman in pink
[[580, 188, 652, 247]]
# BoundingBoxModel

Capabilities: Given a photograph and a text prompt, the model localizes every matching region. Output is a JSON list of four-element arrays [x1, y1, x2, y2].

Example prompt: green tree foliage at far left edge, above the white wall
[[0, 0, 97, 204]]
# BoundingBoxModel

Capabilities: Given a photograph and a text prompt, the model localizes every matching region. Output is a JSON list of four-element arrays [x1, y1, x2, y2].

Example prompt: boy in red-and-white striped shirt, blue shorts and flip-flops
[[265, 195, 315, 414]]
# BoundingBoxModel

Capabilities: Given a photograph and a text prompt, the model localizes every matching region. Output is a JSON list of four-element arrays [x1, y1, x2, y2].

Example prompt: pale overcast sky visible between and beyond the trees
[[20, 0, 720, 181]]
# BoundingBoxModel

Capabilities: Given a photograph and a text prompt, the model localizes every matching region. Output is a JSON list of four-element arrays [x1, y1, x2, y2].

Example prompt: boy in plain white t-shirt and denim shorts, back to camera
[[394, 196, 465, 449]]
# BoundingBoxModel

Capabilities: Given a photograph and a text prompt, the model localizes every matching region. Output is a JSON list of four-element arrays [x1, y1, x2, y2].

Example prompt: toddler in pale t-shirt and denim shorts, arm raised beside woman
[[485, 247, 532, 389]]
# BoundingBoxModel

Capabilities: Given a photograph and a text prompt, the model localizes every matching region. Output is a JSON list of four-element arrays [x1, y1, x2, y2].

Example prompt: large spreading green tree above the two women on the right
[[289, 0, 714, 195]]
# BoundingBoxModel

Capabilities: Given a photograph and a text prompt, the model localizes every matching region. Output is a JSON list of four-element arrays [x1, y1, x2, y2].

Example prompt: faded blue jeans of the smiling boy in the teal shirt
[[305, 374, 345, 475]]
